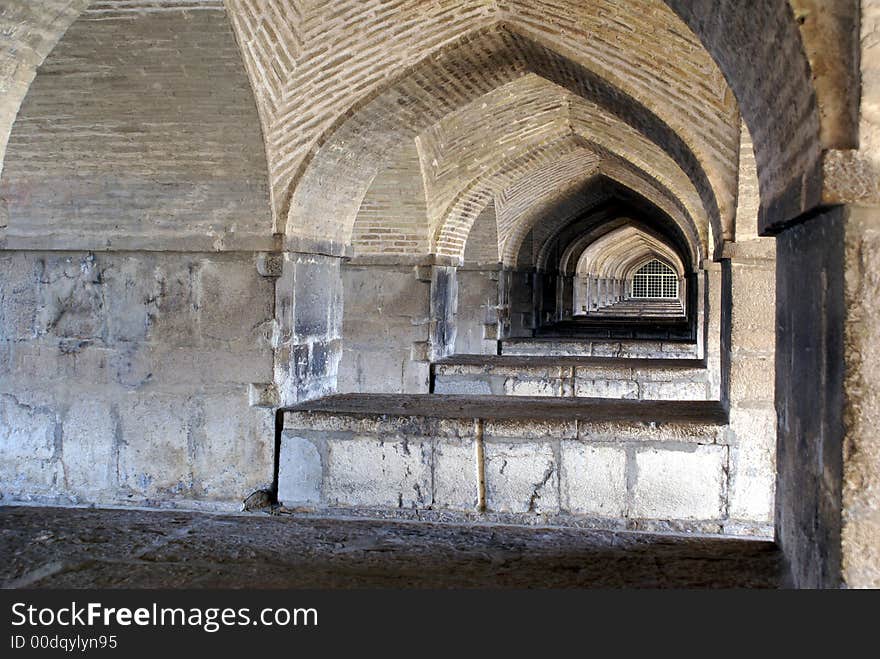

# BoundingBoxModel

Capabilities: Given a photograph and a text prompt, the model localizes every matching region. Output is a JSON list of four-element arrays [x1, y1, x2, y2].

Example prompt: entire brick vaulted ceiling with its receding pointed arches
[[0, 0, 839, 257]]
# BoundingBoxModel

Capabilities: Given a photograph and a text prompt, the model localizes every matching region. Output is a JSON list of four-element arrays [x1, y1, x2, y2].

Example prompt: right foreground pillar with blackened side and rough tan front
[[776, 204, 880, 588]]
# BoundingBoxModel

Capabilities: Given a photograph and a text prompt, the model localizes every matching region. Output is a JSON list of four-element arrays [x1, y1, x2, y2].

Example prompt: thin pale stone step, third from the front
[[499, 336, 700, 359]]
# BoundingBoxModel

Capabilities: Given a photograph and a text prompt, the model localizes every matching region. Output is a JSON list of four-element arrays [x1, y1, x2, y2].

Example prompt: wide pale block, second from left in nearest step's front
[[324, 438, 431, 508]]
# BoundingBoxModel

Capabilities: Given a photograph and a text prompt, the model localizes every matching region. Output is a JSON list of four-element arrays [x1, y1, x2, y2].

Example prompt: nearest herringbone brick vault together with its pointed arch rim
[[228, 0, 739, 260]]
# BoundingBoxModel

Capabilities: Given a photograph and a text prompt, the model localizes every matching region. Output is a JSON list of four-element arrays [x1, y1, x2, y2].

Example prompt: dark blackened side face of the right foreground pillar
[[776, 209, 846, 588]]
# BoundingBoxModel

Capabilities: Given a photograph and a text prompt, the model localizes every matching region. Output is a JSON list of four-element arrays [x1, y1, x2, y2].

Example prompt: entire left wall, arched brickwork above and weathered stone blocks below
[[0, 6, 276, 508]]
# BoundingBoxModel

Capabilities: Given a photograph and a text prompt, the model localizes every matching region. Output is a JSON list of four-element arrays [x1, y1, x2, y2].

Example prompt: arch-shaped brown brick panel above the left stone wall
[[0, 3, 272, 251]]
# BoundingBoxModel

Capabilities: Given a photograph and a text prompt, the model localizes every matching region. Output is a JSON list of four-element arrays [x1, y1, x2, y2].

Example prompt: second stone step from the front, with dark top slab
[[431, 355, 717, 400]]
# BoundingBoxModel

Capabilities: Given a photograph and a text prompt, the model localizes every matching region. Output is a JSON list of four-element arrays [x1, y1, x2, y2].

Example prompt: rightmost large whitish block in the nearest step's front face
[[630, 446, 727, 520]]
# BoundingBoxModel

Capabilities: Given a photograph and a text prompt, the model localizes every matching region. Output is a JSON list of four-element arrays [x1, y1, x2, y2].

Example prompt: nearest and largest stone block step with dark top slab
[[279, 394, 754, 533]]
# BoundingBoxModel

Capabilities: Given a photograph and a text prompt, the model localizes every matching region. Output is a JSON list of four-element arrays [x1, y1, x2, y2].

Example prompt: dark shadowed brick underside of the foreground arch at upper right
[[666, 0, 822, 231]]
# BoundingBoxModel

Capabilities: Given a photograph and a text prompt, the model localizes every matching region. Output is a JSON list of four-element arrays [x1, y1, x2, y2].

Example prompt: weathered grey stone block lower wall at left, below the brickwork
[[0, 251, 273, 507]]
